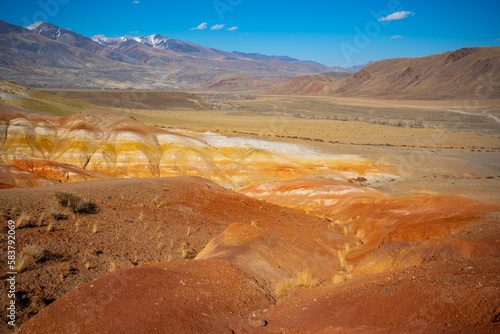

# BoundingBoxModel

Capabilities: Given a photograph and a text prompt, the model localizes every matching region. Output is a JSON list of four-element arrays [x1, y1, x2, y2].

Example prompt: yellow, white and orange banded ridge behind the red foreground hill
[[0, 106, 395, 188]]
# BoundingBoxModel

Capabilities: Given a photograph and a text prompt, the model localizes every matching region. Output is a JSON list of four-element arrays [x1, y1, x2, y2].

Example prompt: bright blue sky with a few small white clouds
[[0, 0, 500, 66]]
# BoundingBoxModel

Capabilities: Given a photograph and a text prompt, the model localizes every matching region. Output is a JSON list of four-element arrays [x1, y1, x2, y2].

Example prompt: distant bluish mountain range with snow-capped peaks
[[0, 20, 346, 89]]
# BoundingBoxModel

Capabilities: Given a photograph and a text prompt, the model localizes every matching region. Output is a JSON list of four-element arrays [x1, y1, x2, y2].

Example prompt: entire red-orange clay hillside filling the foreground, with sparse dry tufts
[[1, 177, 500, 333]]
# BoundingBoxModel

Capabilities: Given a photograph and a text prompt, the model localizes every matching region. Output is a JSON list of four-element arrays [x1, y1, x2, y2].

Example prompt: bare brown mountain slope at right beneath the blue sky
[[267, 47, 500, 100]]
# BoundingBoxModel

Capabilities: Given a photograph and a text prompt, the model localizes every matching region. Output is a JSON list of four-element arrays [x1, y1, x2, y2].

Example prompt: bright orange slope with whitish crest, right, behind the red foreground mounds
[[240, 179, 500, 275]]
